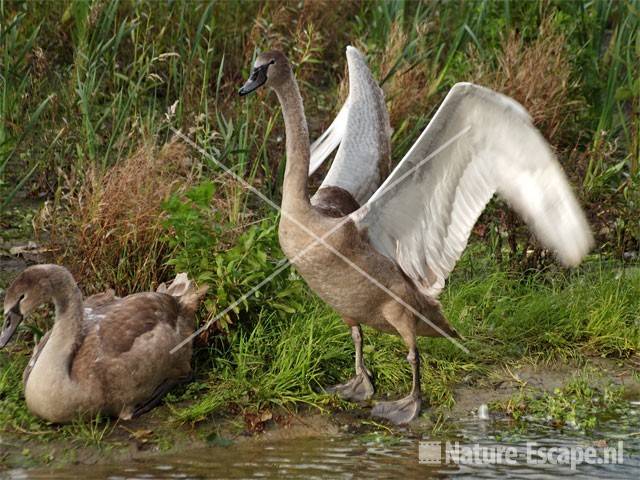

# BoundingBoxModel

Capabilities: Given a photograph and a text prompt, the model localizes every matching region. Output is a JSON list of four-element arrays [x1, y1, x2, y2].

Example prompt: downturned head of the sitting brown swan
[[0, 265, 71, 348]]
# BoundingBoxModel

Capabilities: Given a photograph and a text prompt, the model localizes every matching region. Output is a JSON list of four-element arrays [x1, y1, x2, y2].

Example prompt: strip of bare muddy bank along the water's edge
[[0, 358, 640, 471]]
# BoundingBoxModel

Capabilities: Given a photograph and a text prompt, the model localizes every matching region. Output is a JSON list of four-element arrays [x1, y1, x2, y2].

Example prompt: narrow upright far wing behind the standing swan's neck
[[310, 47, 391, 205]]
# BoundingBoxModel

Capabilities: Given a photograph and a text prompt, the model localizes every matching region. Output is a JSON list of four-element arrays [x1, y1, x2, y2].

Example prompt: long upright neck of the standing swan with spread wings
[[275, 73, 310, 213]]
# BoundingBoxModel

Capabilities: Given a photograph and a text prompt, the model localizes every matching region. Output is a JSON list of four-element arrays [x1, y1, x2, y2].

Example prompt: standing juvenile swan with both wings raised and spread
[[240, 47, 592, 423]]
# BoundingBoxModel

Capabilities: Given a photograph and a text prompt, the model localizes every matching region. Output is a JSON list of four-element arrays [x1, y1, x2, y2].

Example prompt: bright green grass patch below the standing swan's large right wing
[[441, 247, 640, 362]]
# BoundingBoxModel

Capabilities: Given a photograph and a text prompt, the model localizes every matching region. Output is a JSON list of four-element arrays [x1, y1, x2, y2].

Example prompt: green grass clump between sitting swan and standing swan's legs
[[173, 300, 352, 422]]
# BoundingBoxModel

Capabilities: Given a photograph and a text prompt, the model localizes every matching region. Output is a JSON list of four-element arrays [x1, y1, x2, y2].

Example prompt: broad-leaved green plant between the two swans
[[164, 181, 306, 330]]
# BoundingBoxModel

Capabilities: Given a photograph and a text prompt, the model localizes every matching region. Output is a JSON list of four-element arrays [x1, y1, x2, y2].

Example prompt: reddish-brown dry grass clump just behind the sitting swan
[[45, 141, 192, 293]]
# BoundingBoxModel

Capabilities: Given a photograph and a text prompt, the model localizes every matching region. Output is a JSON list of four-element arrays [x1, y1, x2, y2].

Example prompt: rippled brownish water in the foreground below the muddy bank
[[8, 411, 640, 480]]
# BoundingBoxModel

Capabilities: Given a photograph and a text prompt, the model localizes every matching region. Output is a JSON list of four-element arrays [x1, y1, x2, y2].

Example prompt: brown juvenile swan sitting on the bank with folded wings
[[0, 265, 206, 423]]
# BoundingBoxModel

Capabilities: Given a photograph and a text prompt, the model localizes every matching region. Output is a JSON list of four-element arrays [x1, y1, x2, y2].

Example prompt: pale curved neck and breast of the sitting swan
[[25, 272, 88, 418]]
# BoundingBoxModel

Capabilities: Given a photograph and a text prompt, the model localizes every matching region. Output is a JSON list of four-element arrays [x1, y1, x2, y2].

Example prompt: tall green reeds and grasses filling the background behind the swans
[[0, 0, 640, 251]]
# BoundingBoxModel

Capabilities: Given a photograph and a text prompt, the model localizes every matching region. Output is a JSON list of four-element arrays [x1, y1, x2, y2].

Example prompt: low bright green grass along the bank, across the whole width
[[0, 248, 640, 445]]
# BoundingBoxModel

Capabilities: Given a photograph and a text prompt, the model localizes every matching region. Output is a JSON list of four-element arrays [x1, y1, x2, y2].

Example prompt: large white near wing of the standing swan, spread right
[[352, 83, 593, 295]]
